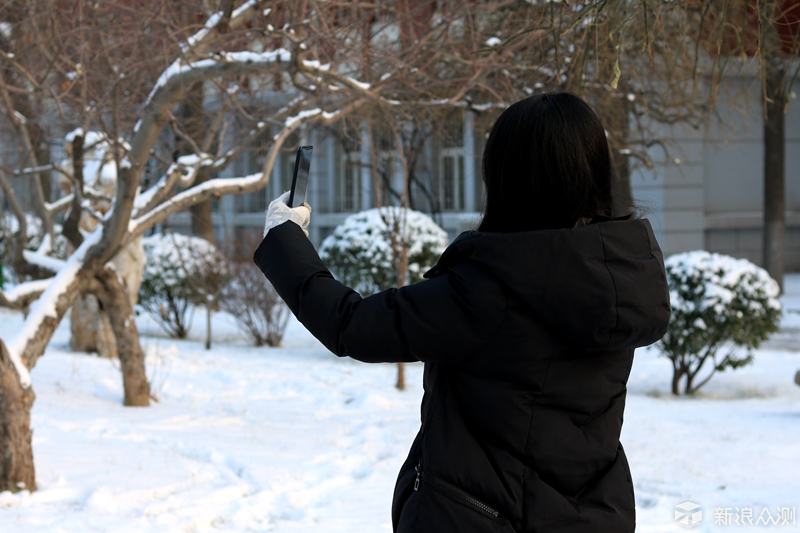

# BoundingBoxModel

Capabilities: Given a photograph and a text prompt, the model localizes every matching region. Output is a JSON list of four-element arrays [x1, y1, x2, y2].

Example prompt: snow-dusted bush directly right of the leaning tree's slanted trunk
[[139, 232, 228, 339]]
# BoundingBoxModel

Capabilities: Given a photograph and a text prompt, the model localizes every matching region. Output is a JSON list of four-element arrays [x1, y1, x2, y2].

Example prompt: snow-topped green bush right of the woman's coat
[[658, 250, 781, 394]]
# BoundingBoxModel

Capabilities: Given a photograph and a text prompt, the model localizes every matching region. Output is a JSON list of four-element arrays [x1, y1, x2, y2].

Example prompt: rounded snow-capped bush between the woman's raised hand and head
[[320, 207, 448, 296]]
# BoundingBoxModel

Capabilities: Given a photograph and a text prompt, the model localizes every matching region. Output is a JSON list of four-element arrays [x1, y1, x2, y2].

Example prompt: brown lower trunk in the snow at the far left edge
[[0, 340, 36, 492]]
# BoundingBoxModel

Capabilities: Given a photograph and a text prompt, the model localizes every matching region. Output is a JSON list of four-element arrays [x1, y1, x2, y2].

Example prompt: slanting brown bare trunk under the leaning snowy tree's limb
[[93, 271, 150, 407]]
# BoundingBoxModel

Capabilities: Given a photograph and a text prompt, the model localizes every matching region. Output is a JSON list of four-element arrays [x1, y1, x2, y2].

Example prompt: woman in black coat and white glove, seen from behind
[[255, 93, 670, 533]]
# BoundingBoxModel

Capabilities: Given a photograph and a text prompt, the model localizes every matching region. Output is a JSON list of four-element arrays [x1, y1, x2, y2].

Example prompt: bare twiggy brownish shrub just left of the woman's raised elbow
[[219, 262, 289, 346]]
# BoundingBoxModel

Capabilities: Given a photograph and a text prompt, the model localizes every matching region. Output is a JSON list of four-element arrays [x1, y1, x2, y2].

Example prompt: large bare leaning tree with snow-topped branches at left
[[0, 0, 520, 491]]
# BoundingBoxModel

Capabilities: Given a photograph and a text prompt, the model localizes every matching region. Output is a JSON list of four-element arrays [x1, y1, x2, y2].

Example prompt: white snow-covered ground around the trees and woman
[[0, 275, 800, 533]]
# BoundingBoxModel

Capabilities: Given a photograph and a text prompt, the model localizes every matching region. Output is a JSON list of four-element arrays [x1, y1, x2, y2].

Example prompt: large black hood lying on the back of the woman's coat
[[425, 219, 670, 351]]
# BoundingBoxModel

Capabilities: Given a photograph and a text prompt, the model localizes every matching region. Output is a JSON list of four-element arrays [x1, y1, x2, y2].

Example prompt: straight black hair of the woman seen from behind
[[478, 93, 613, 232]]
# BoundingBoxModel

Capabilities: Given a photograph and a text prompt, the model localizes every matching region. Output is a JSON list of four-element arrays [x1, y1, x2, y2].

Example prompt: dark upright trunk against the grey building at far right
[[763, 59, 786, 292]]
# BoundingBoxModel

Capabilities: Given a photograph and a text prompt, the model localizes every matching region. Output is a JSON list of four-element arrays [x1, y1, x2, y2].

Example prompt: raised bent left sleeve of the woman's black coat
[[253, 219, 506, 363]]
